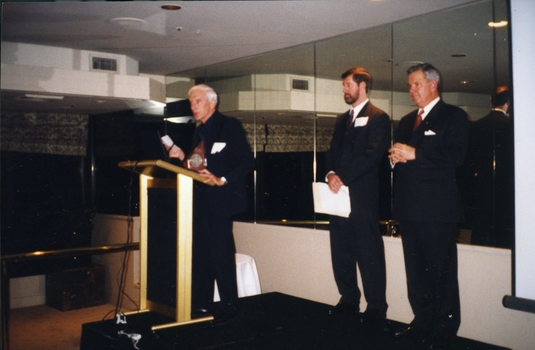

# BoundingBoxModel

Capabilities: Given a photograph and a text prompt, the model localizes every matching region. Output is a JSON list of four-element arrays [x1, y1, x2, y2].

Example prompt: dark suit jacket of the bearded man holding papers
[[325, 102, 390, 216]]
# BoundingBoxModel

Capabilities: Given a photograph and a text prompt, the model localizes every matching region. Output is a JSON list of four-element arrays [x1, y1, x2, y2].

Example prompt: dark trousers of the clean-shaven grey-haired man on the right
[[400, 221, 461, 336]]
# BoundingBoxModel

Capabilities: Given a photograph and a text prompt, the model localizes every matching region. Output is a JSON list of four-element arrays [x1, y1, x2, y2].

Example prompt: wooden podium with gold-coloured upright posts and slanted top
[[119, 160, 214, 330]]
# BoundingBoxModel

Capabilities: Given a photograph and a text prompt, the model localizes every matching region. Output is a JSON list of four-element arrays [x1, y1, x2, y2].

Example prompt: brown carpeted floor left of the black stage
[[9, 305, 130, 350]]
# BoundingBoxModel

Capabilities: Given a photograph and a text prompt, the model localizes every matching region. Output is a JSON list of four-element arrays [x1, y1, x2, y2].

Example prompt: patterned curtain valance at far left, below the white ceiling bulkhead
[[0, 112, 89, 156]]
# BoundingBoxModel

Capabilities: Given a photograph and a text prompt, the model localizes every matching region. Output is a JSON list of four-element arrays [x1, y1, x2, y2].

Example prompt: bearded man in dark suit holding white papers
[[326, 67, 390, 326]]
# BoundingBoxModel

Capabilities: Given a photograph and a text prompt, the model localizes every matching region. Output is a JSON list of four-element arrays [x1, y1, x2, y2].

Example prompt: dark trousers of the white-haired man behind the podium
[[192, 186, 238, 313]]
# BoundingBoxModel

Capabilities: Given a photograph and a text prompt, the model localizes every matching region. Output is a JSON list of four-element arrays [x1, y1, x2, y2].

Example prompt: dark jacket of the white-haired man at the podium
[[195, 111, 254, 215]]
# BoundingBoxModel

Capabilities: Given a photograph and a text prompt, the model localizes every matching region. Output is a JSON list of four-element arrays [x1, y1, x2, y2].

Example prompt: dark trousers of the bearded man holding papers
[[329, 214, 388, 316]]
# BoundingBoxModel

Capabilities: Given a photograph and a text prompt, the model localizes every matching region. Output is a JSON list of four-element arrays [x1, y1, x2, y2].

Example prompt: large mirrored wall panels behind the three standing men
[[168, 0, 514, 247]]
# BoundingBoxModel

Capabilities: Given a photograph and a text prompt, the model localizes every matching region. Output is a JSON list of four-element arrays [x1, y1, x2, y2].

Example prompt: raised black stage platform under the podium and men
[[80, 293, 510, 350]]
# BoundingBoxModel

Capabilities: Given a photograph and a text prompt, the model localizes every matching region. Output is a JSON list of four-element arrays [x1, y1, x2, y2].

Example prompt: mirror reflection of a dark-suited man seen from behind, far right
[[467, 85, 514, 248]]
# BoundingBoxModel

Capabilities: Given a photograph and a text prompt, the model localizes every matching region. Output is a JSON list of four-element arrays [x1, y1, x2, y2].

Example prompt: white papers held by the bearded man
[[312, 182, 351, 218]]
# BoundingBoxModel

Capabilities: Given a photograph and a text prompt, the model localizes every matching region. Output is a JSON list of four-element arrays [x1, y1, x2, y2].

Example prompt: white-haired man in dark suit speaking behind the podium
[[168, 84, 254, 324]]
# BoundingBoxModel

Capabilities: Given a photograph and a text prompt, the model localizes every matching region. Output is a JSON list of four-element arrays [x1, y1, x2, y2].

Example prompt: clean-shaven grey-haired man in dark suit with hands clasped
[[389, 63, 469, 347]]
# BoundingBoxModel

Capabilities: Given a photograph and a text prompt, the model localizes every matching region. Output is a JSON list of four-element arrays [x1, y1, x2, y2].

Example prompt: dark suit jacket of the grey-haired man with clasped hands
[[394, 100, 469, 222]]
